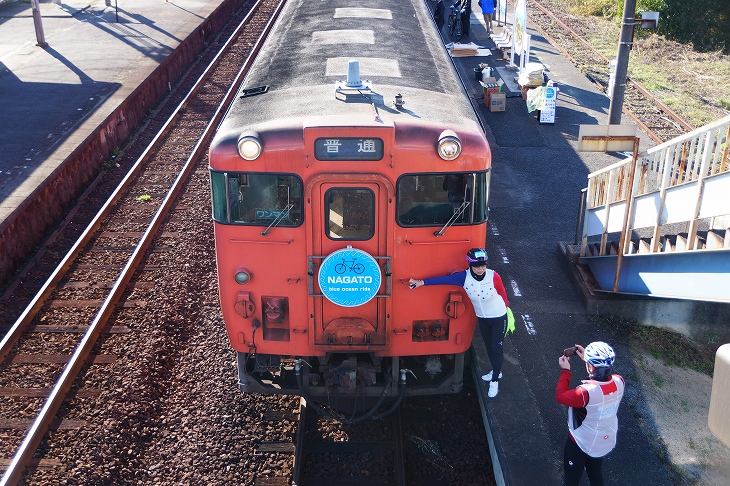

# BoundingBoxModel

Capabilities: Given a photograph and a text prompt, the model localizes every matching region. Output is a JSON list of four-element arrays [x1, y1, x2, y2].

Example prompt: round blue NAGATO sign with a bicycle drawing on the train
[[318, 246, 381, 307]]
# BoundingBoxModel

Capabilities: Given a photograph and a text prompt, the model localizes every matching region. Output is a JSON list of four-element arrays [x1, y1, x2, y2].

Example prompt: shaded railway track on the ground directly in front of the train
[[253, 380, 496, 486]]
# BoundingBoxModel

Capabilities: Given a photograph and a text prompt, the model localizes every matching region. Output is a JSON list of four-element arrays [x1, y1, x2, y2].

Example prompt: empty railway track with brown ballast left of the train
[[0, 0, 283, 485]]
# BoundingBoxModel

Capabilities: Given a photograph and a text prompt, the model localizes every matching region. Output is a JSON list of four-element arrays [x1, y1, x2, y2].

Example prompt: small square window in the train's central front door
[[324, 188, 375, 240]]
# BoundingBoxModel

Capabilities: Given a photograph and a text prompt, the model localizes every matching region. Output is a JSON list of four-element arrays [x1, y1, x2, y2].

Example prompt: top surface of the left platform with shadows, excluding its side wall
[[0, 0, 224, 226]]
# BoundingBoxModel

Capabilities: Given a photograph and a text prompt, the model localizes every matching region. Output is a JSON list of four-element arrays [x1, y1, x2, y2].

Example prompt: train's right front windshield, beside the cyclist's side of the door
[[397, 172, 490, 226]]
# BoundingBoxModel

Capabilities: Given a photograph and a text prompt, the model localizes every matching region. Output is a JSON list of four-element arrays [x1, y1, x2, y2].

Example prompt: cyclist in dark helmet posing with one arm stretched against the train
[[409, 248, 509, 398]]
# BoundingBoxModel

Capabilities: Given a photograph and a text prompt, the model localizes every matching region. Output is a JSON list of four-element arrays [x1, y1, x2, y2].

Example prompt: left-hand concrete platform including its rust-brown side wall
[[0, 0, 243, 282]]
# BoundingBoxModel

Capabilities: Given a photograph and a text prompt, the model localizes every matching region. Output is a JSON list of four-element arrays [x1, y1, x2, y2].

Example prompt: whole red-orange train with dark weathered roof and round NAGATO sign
[[210, 0, 491, 408]]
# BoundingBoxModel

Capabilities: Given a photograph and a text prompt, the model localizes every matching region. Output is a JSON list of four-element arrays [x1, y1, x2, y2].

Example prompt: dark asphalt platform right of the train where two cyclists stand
[[436, 1, 674, 486]]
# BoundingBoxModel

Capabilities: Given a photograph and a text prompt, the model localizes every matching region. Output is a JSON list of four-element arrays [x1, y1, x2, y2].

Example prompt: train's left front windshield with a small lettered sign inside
[[210, 171, 303, 226]]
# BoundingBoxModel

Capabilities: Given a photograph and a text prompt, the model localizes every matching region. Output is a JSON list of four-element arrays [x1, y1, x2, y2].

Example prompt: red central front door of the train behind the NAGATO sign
[[309, 175, 392, 351]]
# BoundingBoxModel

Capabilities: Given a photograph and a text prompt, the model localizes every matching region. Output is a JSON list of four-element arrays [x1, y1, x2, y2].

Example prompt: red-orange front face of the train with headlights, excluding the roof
[[211, 109, 490, 403]]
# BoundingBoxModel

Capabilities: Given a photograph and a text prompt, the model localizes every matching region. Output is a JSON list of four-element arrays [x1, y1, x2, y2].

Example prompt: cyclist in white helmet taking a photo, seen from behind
[[555, 341, 624, 486]]
